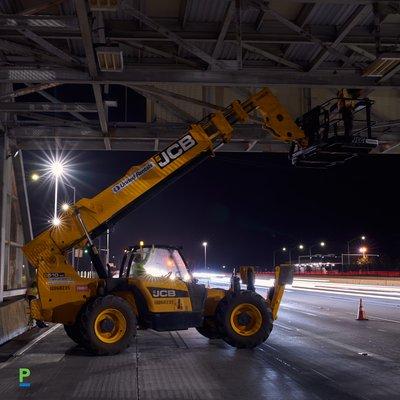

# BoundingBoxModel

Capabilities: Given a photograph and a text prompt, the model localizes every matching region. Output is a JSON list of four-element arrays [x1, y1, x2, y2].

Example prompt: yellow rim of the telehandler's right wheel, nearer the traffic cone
[[230, 303, 262, 336]]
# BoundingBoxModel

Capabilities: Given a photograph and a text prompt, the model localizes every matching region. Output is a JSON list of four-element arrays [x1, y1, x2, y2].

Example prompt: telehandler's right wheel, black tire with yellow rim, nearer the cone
[[216, 290, 273, 348]]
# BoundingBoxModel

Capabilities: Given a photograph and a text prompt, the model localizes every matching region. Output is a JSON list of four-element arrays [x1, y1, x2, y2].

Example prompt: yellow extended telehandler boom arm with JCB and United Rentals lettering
[[23, 88, 304, 279]]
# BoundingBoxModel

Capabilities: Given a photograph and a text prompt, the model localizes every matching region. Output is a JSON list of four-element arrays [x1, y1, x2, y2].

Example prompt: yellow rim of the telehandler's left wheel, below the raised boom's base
[[94, 308, 126, 343]]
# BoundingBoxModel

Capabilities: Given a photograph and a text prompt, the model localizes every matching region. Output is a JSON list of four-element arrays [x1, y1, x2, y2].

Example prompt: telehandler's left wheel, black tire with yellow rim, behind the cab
[[80, 295, 137, 356]]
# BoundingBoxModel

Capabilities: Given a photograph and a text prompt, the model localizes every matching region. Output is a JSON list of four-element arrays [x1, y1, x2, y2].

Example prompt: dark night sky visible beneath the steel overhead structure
[[24, 151, 400, 268]]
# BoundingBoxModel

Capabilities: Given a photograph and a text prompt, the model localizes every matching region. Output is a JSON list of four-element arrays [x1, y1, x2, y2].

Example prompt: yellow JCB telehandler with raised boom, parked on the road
[[23, 88, 373, 355]]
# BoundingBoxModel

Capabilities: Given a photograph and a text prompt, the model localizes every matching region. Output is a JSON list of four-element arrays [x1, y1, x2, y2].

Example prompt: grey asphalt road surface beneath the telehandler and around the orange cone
[[0, 289, 400, 400]]
